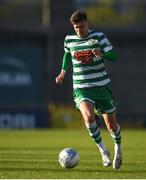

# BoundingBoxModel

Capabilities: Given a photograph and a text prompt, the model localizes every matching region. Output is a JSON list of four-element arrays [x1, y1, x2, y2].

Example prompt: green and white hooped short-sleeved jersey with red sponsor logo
[[64, 31, 113, 89]]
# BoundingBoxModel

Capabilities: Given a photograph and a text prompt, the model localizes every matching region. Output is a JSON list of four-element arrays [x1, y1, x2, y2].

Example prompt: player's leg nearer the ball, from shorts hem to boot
[[79, 101, 111, 167]]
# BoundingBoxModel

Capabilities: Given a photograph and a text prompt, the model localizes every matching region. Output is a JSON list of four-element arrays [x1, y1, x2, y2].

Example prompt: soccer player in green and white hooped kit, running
[[56, 11, 122, 169]]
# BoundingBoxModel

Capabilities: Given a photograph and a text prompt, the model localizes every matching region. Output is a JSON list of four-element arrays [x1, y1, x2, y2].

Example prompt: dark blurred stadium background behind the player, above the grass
[[0, 0, 146, 128]]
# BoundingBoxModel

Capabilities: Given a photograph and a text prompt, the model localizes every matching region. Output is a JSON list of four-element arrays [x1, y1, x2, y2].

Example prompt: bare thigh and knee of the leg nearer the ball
[[79, 100, 95, 123]]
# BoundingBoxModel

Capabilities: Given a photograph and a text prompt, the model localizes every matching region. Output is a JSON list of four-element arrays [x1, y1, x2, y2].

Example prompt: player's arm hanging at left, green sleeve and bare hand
[[56, 52, 71, 84]]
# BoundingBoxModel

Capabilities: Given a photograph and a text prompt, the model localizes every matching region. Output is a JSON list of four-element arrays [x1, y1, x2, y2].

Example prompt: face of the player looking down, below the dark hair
[[73, 21, 89, 38]]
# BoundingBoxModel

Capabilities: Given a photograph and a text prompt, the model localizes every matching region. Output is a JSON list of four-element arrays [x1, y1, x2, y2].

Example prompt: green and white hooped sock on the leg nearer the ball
[[85, 121, 107, 152]]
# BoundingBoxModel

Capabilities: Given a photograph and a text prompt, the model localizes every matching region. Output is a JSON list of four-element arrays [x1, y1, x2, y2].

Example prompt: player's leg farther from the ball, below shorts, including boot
[[103, 112, 122, 169]]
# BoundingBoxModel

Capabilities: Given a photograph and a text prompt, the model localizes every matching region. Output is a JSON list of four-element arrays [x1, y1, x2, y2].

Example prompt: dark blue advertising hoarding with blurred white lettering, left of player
[[0, 43, 47, 128]]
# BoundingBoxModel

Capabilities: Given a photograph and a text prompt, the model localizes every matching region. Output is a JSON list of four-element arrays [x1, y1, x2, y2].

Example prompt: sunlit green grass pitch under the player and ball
[[0, 129, 146, 179]]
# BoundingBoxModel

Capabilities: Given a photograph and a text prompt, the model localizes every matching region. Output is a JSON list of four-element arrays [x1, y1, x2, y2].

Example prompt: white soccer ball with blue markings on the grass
[[59, 148, 80, 168]]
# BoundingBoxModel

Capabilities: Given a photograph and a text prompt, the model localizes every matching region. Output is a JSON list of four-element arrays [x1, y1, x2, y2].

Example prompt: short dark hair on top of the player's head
[[70, 10, 87, 24]]
